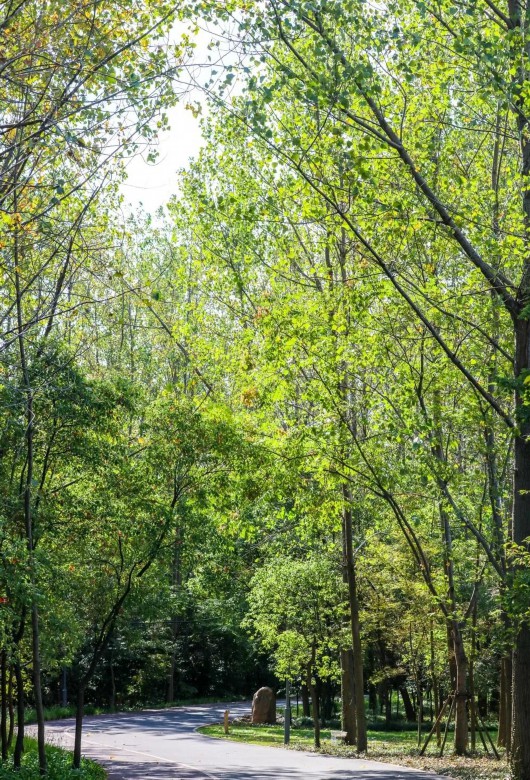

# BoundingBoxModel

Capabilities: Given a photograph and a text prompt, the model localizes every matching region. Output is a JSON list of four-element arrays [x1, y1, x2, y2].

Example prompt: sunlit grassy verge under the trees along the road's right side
[[199, 722, 508, 780]]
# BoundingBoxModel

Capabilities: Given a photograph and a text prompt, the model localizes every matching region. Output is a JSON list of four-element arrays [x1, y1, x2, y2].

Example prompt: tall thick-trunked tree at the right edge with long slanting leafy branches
[[189, 0, 530, 768]]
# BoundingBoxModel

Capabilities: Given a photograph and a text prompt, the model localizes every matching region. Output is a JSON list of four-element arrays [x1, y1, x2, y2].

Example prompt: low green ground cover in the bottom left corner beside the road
[[0, 739, 107, 780]]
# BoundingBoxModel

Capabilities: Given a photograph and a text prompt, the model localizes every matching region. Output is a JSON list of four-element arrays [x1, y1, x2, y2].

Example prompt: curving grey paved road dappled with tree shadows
[[36, 702, 447, 780]]
